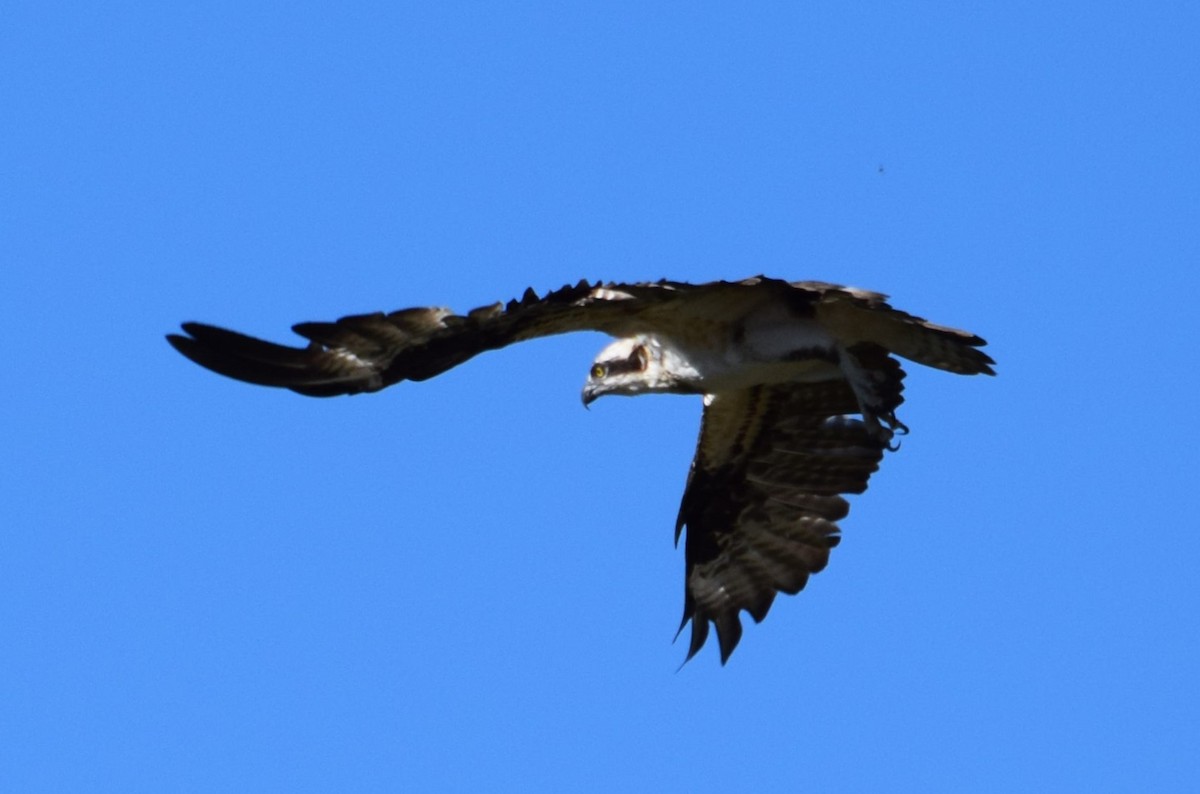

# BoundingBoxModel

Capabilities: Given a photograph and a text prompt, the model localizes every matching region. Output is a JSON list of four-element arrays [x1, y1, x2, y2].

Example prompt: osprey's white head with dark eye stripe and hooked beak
[[583, 336, 697, 407]]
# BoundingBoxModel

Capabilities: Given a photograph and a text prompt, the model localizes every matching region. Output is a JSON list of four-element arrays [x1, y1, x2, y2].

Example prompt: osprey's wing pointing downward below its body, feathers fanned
[[676, 344, 904, 664]]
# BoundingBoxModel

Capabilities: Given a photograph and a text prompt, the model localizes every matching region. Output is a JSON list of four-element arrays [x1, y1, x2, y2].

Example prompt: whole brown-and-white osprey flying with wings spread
[[167, 276, 995, 664]]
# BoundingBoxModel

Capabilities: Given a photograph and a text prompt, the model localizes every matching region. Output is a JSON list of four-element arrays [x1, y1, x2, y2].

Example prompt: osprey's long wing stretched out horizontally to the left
[[167, 278, 803, 397]]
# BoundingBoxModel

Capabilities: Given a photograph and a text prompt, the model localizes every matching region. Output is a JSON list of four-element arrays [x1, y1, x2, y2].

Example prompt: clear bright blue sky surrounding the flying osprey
[[0, 1, 1200, 792]]
